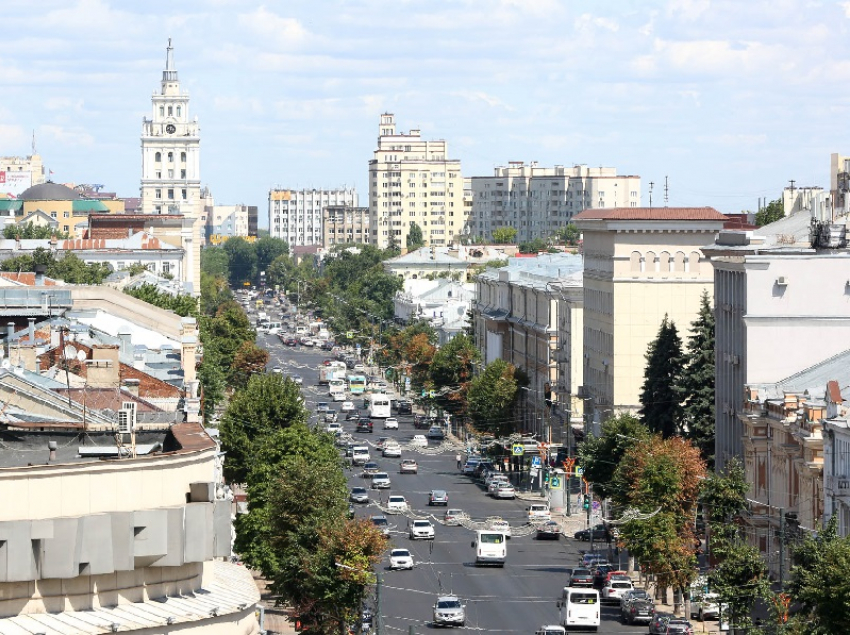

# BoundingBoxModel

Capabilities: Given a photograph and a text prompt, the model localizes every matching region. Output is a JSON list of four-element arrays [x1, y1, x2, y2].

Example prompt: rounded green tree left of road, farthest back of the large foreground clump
[[219, 374, 308, 483]]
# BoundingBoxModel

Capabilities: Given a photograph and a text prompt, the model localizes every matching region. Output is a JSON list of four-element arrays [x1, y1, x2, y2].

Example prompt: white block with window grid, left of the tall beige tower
[[269, 188, 359, 247]]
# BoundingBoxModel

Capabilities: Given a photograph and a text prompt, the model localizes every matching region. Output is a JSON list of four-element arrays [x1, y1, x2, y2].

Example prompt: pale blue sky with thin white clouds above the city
[[0, 0, 850, 227]]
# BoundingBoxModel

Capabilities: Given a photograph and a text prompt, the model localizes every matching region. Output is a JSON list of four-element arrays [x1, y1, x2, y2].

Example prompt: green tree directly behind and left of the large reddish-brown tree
[[578, 413, 650, 498]]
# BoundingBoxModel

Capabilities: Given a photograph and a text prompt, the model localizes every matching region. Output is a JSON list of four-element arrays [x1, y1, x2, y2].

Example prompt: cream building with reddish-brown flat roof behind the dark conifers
[[575, 207, 726, 432]]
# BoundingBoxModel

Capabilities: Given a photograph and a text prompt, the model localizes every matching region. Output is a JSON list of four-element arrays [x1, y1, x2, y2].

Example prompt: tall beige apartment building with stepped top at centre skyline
[[369, 113, 466, 248]]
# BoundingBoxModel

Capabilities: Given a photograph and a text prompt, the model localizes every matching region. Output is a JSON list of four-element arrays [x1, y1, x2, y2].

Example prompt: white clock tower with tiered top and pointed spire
[[141, 38, 203, 294]]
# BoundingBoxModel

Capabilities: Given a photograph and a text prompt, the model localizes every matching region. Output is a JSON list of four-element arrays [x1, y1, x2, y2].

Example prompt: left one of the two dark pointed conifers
[[640, 315, 684, 438]]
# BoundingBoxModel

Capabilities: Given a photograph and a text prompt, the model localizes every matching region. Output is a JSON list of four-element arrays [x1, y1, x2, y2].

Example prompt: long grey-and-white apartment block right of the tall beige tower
[[469, 161, 640, 242]]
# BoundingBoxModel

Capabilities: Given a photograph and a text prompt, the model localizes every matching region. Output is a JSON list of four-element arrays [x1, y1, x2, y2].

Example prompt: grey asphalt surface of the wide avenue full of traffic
[[259, 336, 647, 635]]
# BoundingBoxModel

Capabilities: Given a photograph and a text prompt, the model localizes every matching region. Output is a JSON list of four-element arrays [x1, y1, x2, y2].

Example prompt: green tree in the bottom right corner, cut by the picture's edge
[[788, 516, 850, 635]]
